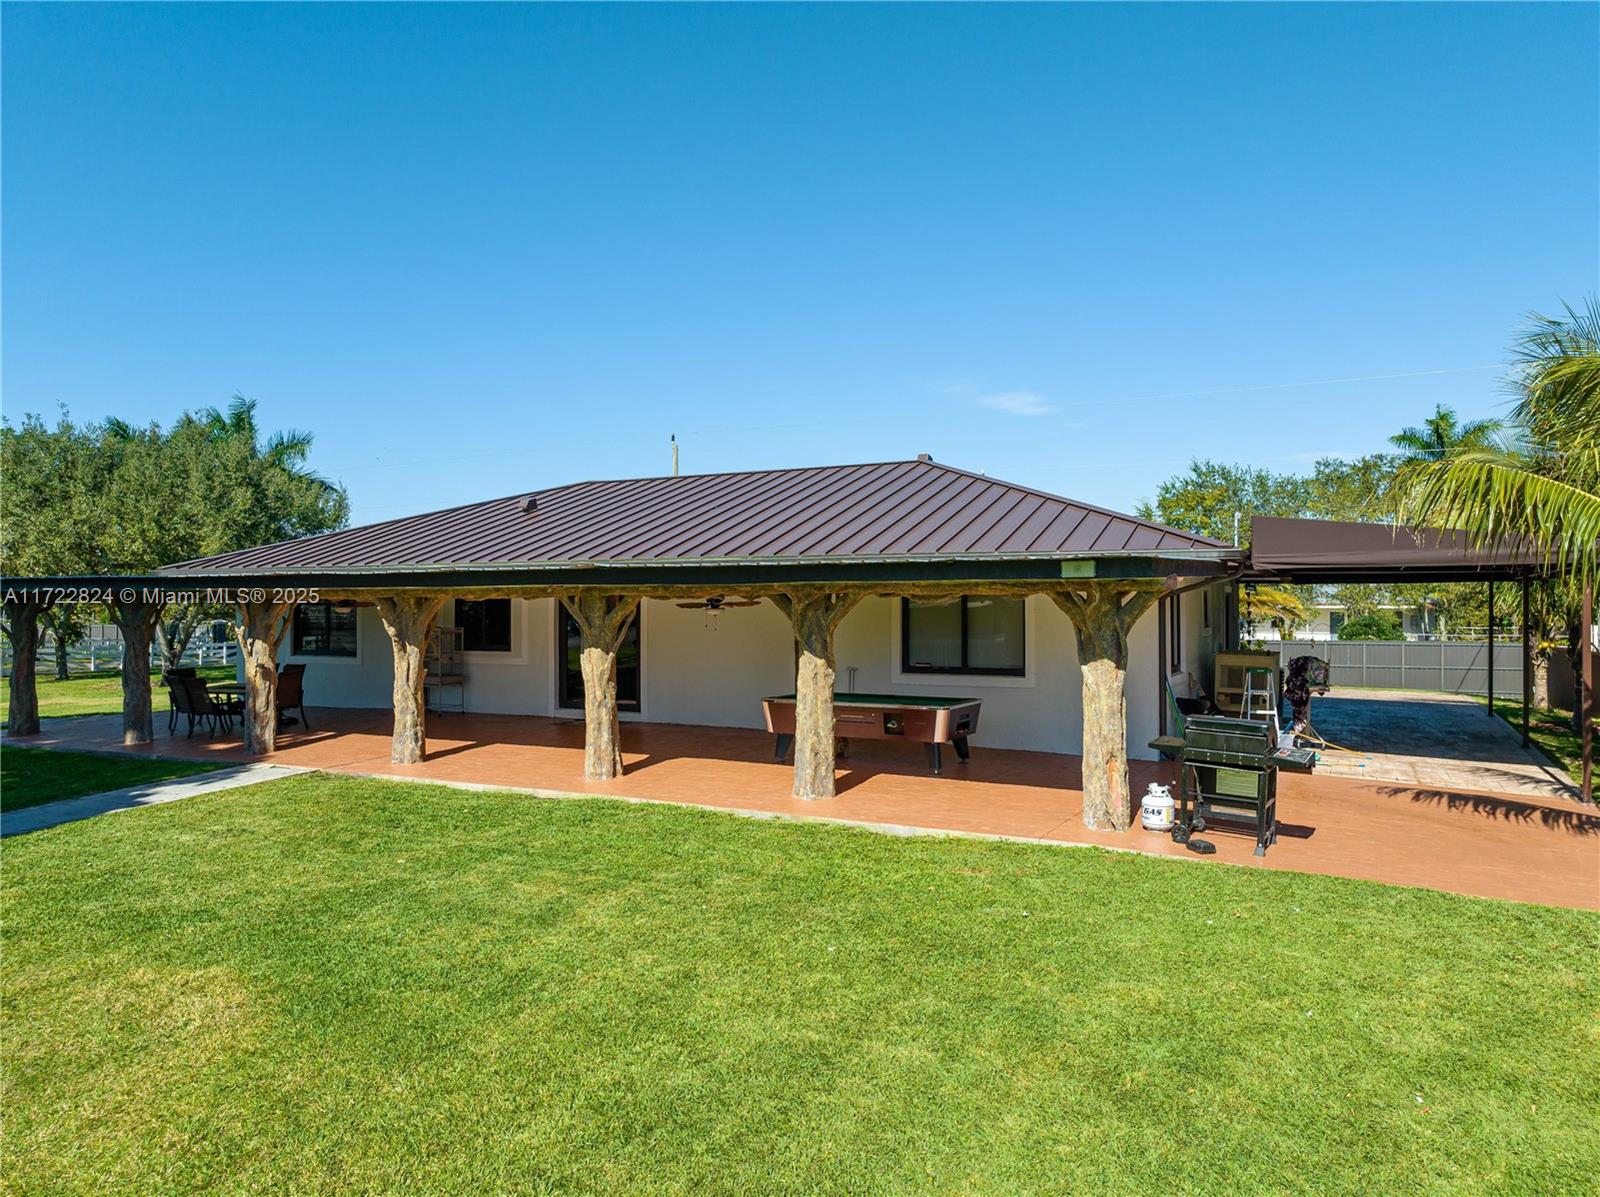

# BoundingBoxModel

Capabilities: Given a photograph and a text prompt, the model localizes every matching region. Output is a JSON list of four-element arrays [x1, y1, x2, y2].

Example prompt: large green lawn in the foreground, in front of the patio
[[0, 775, 1600, 1197]]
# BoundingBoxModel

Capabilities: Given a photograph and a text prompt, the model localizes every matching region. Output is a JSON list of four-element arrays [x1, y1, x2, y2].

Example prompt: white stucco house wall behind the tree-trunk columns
[[282, 595, 1190, 757]]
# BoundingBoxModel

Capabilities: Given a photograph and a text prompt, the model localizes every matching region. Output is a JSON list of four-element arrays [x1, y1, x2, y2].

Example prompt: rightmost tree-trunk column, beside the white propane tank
[[1050, 582, 1170, 831]]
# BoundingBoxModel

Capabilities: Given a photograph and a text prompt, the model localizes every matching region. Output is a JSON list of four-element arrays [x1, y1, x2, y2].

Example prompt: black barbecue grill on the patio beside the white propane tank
[[1173, 715, 1317, 856]]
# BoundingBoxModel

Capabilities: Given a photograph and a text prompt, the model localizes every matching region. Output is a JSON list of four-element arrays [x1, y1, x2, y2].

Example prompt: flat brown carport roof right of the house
[[1250, 515, 1550, 582]]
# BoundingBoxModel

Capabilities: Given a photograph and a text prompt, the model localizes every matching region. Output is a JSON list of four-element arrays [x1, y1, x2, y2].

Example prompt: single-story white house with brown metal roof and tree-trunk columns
[[0, 456, 1242, 826]]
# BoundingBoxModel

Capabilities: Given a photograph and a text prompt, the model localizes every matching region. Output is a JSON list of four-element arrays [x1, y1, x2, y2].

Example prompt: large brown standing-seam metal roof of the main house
[[168, 459, 1232, 573]]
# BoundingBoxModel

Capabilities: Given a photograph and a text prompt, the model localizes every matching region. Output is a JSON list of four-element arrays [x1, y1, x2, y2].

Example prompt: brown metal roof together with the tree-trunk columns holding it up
[[6, 454, 1243, 831]]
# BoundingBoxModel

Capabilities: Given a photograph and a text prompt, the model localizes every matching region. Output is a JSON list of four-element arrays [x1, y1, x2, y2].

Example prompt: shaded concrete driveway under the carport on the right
[[1310, 690, 1578, 799]]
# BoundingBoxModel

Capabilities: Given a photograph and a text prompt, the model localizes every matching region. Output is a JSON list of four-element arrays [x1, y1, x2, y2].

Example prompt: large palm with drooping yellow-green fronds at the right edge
[[1400, 296, 1600, 582]]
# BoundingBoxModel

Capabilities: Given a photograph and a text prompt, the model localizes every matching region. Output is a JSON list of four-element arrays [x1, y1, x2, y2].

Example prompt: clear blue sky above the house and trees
[[0, 5, 1600, 522]]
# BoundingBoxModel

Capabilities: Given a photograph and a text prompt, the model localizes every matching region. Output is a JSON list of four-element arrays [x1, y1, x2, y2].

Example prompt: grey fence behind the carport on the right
[[1264, 640, 1522, 696]]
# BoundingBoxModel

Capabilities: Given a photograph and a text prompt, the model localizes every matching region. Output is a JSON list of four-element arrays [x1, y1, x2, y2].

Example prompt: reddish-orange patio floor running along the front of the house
[[18, 707, 1600, 909]]
